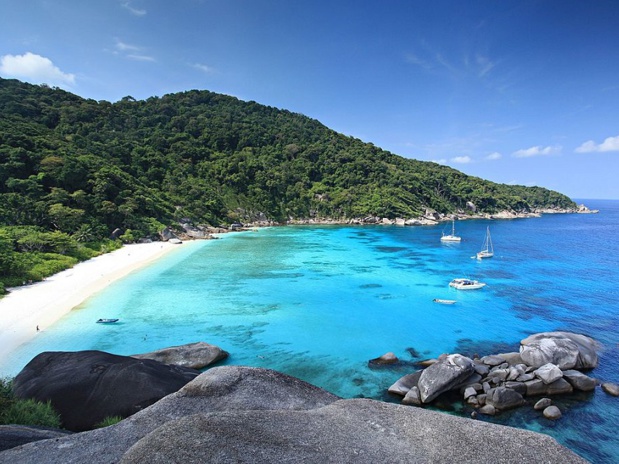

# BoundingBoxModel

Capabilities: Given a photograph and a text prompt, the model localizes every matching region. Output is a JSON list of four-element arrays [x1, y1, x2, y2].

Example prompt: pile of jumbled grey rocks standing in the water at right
[[388, 332, 619, 419]]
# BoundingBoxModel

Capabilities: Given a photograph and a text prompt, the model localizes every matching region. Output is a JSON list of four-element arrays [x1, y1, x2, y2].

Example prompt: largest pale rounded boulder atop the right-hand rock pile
[[520, 332, 598, 370]]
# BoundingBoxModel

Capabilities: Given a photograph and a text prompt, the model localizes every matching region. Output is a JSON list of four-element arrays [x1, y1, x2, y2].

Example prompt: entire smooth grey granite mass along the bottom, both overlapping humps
[[0, 366, 586, 464]]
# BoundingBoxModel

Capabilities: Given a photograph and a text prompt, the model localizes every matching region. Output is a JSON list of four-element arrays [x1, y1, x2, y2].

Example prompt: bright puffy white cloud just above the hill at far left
[[0, 52, 75, 86]]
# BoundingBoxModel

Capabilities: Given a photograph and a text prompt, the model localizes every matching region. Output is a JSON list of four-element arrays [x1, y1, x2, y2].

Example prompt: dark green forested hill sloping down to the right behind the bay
[[0, 79, 575, 238]]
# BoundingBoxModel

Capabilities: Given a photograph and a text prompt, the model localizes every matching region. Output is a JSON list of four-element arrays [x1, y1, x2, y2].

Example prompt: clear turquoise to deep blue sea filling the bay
[[0, 200, 619, 463]]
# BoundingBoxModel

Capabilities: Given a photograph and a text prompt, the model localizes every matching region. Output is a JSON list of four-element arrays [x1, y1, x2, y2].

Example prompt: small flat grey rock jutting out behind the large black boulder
[[131, 342, 228, 369]]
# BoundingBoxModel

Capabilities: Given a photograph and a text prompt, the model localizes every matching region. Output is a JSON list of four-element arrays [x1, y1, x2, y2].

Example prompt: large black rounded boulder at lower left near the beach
[[13, 351, 199, 431]]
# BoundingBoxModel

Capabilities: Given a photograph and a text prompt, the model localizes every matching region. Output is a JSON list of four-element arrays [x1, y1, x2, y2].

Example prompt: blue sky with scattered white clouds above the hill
[[0, 0, 619, 199]]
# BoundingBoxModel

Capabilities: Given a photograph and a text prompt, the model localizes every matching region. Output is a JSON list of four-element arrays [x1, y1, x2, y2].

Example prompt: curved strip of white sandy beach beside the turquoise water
[[0, 242, 183, 357]]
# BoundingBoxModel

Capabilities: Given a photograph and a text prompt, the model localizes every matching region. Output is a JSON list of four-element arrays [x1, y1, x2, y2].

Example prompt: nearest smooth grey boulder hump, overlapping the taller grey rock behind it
[[120, 399, 585, 464]]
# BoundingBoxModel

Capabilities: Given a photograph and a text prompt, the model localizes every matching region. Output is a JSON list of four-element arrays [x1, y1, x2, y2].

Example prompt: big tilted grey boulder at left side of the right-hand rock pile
[[417, 354, 475, 403]]
